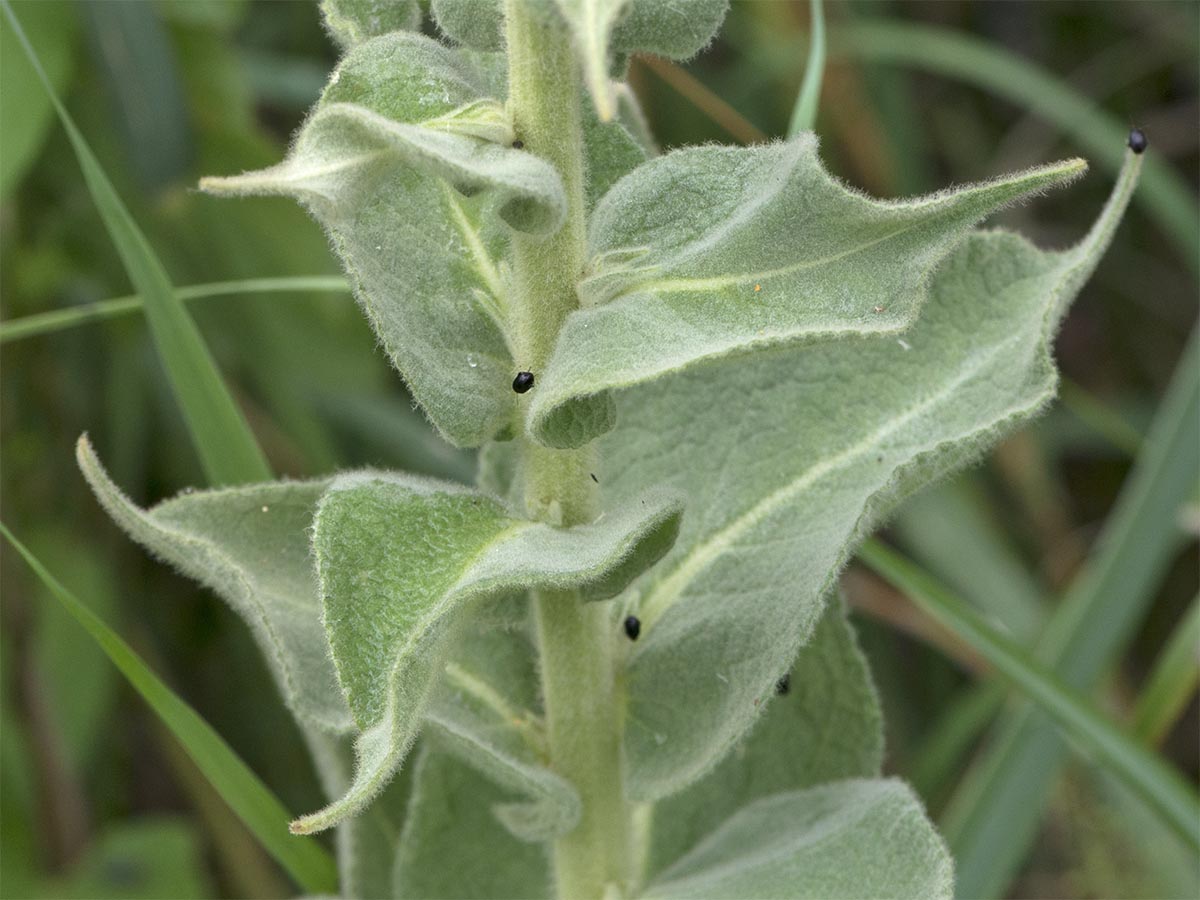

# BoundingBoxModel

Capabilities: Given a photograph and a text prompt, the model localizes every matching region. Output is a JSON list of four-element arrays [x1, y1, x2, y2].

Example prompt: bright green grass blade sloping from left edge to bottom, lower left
[[0, 523, 337, 894]]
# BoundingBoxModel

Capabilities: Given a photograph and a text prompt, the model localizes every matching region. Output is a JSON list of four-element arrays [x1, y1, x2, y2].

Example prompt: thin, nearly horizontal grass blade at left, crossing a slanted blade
[[0, 275, 350, 343]]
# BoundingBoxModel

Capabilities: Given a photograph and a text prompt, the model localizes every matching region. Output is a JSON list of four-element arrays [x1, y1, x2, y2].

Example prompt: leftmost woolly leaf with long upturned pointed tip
[[77, 438, 353, 732]]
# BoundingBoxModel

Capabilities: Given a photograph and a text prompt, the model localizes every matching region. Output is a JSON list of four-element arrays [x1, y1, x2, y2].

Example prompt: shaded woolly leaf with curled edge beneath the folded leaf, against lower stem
[[424, 619, 580, 841]]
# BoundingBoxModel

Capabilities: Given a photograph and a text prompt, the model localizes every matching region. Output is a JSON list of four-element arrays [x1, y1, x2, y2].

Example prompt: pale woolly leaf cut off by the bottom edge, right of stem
[[643, 780, 954, 900]]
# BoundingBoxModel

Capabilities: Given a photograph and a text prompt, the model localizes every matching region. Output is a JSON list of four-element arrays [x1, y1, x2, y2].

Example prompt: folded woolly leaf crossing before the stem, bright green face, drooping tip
[[293, 473, 680, 833]]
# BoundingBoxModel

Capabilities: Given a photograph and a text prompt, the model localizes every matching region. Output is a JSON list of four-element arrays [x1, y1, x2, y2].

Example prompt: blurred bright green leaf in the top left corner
[[0, 0, 79, 199]]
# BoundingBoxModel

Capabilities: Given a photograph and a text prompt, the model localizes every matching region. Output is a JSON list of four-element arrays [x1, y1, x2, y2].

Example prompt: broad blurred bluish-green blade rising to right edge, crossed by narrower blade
[[942, 334, 1200, 898]]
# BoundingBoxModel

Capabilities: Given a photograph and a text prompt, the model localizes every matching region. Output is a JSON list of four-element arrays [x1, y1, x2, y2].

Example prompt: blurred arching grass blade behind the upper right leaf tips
[[834, 20, 1200, 271]]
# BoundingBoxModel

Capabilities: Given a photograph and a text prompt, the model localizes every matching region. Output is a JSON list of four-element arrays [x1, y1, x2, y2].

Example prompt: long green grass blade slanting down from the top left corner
[[4, 0, 271, 485]]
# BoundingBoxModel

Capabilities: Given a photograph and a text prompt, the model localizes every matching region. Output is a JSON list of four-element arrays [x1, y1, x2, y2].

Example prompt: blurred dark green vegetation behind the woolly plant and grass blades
[[0, 0, 1200, 898]]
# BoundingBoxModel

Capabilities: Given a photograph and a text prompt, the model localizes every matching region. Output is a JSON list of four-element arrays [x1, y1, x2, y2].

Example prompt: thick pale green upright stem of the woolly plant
[[506, 0, 631, 900]]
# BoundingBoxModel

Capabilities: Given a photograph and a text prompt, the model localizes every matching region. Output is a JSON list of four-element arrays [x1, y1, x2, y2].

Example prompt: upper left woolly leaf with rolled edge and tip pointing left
[[202, 32, 565, 446]]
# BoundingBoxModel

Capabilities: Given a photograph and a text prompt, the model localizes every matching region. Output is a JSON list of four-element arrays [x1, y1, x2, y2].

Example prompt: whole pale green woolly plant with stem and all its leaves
[[79, 0, 1140, 900]]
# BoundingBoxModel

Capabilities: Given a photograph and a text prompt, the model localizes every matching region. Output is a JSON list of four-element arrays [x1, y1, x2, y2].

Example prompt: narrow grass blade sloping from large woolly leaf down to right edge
[[858, 540, 1200, 851]]
